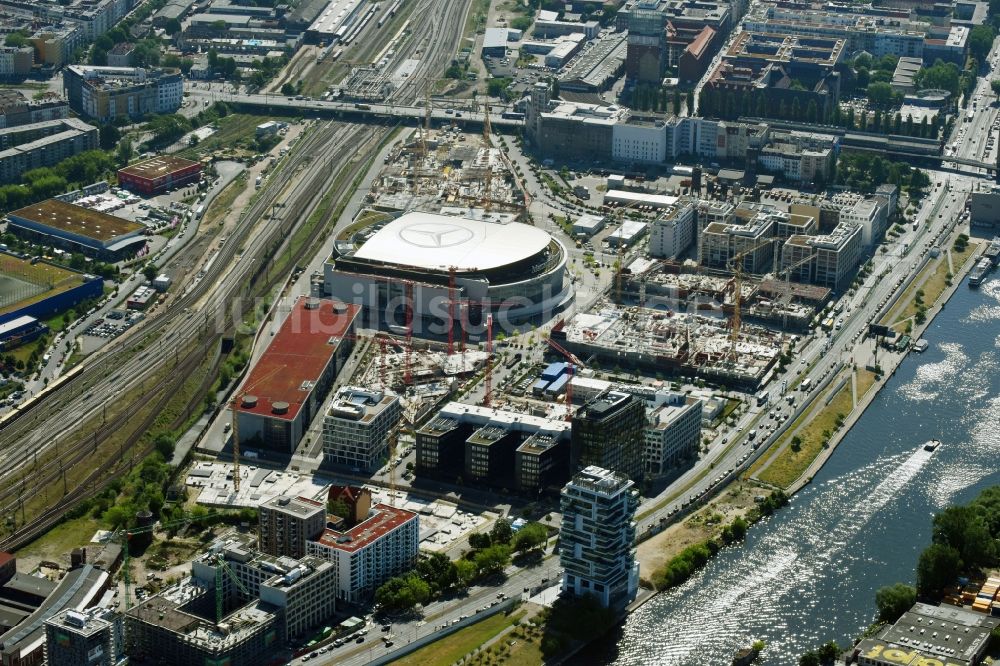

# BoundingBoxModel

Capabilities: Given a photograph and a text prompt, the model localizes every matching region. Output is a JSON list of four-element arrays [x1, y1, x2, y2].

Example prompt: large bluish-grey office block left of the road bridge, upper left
[[63, 65, 184, 123]]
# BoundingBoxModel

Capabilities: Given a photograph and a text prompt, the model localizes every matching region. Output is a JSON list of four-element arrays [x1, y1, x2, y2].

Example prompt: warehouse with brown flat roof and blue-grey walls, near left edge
[[7, 199, 146, 261]]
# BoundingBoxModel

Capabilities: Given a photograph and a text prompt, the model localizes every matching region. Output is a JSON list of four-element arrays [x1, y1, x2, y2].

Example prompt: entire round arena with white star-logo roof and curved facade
[[324, 212, 572, 335]]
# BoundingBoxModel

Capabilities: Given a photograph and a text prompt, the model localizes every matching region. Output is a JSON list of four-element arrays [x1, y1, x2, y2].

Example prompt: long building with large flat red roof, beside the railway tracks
[[233, 297, 360, 453]]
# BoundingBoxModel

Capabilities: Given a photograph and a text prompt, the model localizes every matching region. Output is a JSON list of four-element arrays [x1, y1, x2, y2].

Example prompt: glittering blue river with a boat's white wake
[[586, 278, 1000, 666]]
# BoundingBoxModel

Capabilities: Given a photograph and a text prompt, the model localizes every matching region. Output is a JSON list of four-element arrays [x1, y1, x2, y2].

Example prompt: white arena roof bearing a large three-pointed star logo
[[354, 212, 551, 272]]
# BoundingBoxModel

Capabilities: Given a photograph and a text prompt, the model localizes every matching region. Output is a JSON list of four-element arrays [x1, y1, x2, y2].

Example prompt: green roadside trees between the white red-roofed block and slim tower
[[375, 519, 548, 612]]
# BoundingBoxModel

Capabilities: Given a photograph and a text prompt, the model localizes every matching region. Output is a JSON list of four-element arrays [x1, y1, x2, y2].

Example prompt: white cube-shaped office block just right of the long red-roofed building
[[323, 386, 403, 472]]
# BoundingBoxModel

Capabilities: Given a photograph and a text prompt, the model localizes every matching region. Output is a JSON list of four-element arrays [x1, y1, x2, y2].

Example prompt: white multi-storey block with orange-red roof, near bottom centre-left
[[307, 504, 420, 604]]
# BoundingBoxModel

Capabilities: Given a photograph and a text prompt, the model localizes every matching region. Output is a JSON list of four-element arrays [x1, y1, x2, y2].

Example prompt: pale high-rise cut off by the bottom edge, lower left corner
[[45, 607, 128, 666]]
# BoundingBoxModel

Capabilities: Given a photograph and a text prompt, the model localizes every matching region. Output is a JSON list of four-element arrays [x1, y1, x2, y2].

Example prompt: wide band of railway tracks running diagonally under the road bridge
[[0, 0, 476, 549]]
